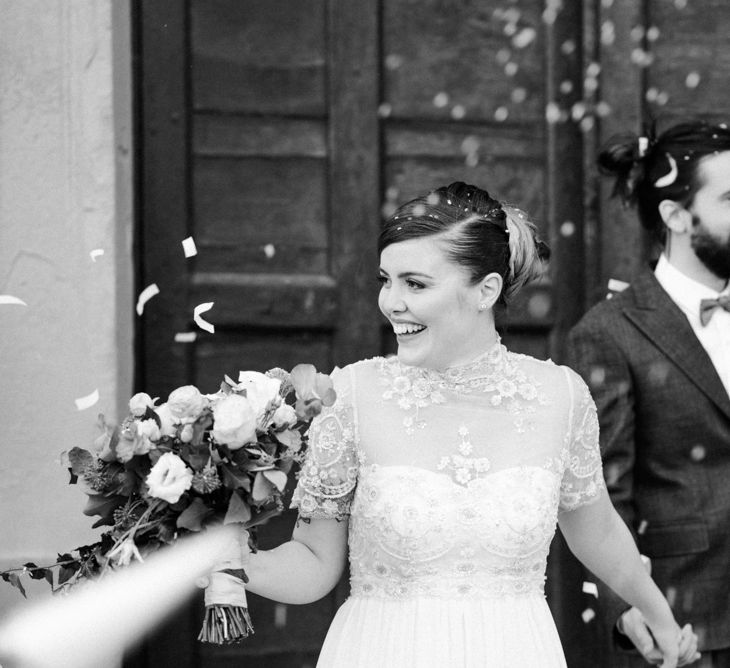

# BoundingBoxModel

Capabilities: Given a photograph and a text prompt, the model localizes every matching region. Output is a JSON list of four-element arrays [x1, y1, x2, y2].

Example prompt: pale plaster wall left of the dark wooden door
[[0, 0, 134, 616]]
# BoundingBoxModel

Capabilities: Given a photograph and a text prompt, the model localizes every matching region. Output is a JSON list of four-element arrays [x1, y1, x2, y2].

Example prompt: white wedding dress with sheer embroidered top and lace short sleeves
[[293, 342, 605, 668]]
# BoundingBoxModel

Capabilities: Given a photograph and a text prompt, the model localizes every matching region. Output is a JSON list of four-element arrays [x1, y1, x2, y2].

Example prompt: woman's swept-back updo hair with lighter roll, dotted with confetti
[[378, 181, 550, 304]]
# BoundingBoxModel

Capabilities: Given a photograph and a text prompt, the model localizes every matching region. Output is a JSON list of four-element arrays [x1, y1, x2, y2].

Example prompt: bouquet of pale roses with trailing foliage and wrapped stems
[[0, 364, 335, 644]]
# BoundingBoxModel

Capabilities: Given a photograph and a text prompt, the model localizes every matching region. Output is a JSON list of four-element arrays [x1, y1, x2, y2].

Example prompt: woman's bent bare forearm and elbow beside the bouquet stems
[[246, 519, 348, 603]]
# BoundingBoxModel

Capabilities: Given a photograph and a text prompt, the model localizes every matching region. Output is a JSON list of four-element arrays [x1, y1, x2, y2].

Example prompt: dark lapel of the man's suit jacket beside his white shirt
[[624, 272, 730, 418]]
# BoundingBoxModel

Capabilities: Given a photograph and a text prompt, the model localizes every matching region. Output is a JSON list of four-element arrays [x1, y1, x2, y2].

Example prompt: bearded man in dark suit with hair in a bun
[[568, 117, 730, 668]]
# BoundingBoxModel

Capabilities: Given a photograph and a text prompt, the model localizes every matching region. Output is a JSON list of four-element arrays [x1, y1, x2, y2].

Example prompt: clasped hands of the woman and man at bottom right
[[618, 608, 700, 668]]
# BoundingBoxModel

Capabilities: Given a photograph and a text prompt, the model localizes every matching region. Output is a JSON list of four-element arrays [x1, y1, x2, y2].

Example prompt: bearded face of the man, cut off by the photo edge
[[690, 151, 730, 280]]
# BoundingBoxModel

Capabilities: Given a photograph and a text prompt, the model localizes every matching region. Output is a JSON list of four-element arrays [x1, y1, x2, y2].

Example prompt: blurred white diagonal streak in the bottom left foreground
[[0, 525, 238, 668]]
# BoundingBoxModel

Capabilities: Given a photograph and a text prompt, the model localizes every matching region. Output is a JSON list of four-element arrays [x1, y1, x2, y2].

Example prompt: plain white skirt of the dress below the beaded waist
[[317, 594, 566, 668]]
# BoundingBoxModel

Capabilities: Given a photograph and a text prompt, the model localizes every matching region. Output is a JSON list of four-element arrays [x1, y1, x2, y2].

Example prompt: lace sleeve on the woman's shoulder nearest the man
[[560, 369, 606, 511]]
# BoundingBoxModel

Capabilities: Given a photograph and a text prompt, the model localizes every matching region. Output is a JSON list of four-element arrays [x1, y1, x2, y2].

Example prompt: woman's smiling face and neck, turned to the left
[[378, 236, 491, 369]]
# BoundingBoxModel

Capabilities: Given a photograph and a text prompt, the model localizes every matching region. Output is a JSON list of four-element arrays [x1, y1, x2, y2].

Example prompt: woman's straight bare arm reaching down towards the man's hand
[[559, 493, 697, 666]]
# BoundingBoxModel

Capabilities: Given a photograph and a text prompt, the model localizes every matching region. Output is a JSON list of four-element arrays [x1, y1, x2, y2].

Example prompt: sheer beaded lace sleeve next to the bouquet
[[290, 369, 358, 520]]
